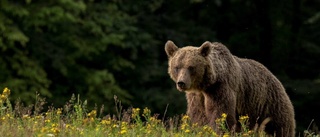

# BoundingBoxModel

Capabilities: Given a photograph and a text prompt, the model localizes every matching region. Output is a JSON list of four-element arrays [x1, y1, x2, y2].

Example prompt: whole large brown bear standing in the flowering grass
[[165, 40, 295, 137]]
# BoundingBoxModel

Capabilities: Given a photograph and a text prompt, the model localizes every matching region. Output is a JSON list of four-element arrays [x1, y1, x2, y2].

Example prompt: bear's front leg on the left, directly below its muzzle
[[186, 92, 209, 125]]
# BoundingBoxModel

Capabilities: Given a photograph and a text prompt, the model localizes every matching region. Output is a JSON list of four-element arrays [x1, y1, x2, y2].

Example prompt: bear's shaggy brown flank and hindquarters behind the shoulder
[[235, 57, 294, 132]]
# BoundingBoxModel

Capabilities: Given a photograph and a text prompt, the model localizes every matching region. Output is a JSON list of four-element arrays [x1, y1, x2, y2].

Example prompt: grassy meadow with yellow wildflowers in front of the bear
[[0, 88, 318, 137]]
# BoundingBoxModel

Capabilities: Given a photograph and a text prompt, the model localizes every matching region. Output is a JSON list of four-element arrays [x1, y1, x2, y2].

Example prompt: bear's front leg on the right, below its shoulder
[[203, 92, 237, 133]]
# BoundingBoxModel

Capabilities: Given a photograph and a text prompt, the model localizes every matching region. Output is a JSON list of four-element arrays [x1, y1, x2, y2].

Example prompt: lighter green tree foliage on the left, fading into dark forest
[[0, 0, 141, 111]]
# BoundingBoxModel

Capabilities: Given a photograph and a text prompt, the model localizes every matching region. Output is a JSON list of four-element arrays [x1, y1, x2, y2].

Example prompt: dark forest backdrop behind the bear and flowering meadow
[[0, 0, 320, 132]]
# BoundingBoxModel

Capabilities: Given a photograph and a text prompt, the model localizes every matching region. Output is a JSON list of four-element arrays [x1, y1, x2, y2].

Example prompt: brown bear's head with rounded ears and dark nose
[[165, 40, 216, 91]]
